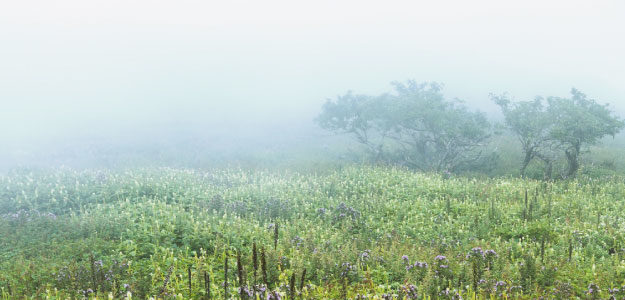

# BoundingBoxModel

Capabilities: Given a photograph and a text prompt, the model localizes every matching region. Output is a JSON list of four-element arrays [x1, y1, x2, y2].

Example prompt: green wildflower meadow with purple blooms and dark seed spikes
[[0, 167, 625, 299]]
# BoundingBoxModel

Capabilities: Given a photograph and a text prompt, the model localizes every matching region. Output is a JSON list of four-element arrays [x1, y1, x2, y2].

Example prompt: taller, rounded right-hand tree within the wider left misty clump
[[387, 81, 490, 172]]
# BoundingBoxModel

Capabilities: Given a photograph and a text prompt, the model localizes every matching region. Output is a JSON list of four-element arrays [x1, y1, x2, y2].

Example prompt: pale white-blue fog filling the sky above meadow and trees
[[0, 0, 625, 168]]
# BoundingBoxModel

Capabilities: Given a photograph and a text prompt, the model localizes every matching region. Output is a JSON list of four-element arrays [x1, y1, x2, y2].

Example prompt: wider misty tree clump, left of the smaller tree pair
[[317, 81, 491, 172]]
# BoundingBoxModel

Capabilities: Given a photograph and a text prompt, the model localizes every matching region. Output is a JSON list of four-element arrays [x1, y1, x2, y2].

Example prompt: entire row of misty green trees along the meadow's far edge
[[316, 81, 625, 179]]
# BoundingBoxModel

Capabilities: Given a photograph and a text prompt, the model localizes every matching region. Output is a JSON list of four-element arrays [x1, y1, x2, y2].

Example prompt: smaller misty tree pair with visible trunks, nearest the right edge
[[493, 89, 625, 178]]
